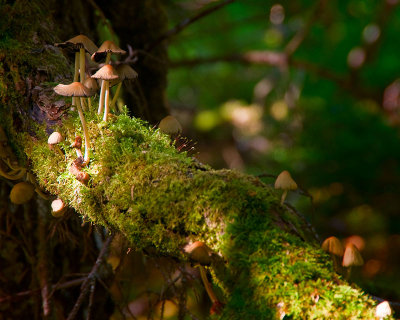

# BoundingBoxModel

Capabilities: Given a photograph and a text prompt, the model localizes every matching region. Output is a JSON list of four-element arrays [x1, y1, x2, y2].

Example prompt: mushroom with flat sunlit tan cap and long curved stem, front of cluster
[[54, 82, 92, 164]]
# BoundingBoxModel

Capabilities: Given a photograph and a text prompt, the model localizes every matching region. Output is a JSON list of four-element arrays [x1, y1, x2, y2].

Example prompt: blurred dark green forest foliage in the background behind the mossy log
[[167, 0, 400, 299]]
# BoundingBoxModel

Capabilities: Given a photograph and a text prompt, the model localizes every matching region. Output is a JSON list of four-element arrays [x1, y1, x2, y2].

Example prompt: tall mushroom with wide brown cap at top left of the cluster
[[55, 34, 97, 83]]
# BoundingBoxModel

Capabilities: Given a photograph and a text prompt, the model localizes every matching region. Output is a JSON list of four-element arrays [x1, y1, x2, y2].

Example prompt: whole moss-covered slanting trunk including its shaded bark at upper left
[[0, 1, 390, 319]]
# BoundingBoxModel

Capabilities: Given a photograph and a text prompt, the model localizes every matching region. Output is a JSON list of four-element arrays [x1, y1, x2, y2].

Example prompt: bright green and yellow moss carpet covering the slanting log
[[27, 112, 386, 319]]
